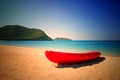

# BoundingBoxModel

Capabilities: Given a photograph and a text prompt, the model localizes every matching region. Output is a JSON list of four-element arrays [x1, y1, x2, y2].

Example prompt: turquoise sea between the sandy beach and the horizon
[[0, 41, 120, 55]]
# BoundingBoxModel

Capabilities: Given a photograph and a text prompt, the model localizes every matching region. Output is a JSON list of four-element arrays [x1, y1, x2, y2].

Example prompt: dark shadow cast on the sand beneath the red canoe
[[55, 57, 105, 69]]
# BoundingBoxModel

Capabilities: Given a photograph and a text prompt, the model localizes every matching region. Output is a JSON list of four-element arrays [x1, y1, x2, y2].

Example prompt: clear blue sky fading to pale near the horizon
[[0, 0, 120, 40]]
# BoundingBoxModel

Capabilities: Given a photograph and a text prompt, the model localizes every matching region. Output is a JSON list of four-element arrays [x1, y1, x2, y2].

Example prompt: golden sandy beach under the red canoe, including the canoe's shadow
[[0, 45, 120, 80]]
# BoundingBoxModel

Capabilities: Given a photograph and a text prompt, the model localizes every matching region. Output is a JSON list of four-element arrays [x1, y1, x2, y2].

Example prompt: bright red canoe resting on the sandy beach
[[45, 51, 101, 64]]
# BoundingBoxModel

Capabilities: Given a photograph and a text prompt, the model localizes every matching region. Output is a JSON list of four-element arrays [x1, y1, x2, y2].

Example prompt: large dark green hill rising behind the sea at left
[[0, 25, 52, 40]]
